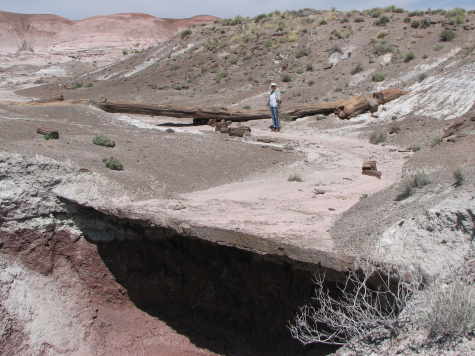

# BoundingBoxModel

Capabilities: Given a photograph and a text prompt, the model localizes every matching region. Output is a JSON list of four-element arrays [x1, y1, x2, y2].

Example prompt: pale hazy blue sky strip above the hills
[[0, 0, 475, 19]]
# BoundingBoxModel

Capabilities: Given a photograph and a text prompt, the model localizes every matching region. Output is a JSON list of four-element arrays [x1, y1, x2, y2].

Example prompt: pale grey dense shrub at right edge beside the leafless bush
[[421, 280, 475, 339]]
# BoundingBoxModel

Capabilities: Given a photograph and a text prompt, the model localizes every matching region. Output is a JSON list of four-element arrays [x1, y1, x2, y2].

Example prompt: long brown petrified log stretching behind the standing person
[[91, 89, 408, 124]]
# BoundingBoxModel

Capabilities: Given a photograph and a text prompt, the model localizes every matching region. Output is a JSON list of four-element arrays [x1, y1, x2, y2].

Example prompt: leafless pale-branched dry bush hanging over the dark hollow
[[289, 262, 421, 345]]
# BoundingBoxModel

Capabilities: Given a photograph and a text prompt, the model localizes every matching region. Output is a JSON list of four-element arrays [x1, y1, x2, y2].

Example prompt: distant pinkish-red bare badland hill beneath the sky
[[0, 11, 215, 64]]
